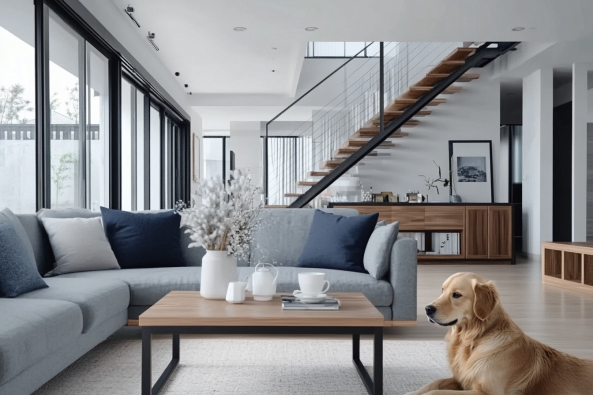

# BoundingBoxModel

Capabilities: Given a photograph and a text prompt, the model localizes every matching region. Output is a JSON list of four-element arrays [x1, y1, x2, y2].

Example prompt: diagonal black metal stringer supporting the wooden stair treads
[[289, 42, 520, 208]]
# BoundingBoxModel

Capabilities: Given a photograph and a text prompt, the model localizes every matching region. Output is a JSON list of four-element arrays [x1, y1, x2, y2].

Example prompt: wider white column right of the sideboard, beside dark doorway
[[523, 69, 554, 255]]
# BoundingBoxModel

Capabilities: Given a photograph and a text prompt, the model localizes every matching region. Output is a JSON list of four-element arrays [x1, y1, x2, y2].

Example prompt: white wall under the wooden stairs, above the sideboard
[[360, 69, 508, 202]]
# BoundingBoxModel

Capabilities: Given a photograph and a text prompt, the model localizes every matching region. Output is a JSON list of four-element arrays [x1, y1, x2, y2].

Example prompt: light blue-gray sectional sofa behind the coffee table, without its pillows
[[0, 209, 417, 395]]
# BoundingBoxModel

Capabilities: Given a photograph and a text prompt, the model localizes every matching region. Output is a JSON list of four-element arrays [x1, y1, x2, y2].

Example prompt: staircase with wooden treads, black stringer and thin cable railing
[[264, 42, 518, 207]]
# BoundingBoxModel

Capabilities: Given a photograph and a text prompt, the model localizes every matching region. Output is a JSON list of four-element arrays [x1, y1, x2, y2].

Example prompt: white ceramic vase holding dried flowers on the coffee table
[[200, 251, 237, 299]]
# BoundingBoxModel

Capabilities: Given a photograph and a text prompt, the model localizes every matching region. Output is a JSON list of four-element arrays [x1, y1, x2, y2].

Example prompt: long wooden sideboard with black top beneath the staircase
[[329, 203, 515, 264]]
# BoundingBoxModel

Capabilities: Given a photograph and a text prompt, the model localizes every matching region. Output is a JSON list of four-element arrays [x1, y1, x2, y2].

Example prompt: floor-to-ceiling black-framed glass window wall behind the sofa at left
[[0, 0, 190, 213]]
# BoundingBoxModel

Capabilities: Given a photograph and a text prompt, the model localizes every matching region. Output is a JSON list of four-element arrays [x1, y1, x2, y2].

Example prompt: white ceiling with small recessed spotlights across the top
[[112, 0, 593, 96]]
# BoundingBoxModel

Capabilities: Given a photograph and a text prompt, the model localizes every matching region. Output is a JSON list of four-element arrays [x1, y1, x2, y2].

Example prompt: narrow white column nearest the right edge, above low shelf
[[572, 64, 588, 241]]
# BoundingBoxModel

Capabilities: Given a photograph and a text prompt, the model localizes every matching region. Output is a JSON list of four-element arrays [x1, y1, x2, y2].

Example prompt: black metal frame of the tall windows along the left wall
[[34, 0, 191, 210]]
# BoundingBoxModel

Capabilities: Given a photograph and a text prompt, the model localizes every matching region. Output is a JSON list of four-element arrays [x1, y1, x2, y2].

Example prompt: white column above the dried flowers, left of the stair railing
[[230, 121, 262, 186]]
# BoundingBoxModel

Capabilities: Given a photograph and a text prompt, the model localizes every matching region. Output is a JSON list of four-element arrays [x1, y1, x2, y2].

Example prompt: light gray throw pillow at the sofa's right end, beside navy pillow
[[363, 221, 399, 280]]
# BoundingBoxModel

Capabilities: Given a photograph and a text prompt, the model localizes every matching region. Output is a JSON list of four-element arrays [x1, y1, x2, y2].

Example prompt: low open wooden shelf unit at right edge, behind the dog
[[542, 242, 593, 294]]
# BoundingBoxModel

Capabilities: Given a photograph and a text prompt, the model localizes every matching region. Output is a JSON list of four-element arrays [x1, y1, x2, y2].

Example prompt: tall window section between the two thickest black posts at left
[[49, 10, 109, 211]]
